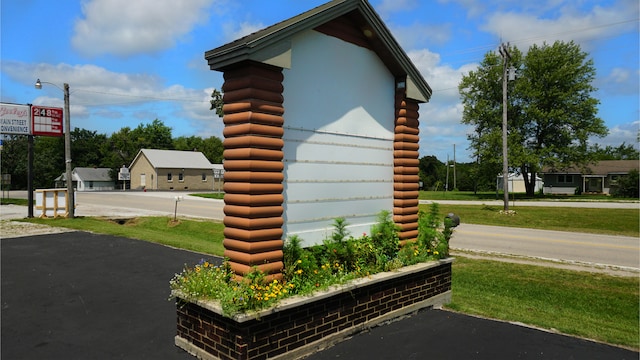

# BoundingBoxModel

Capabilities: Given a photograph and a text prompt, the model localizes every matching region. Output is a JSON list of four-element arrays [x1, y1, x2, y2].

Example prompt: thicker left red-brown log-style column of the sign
[[222, 62, 284, 280]]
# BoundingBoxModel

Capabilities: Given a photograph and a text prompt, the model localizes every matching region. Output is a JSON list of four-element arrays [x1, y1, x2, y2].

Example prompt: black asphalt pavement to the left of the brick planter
[[0, 231, 222, 359]]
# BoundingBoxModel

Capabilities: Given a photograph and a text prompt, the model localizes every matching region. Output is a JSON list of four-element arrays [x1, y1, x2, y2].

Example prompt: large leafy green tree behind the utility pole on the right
[[459, 41, 607, 196]]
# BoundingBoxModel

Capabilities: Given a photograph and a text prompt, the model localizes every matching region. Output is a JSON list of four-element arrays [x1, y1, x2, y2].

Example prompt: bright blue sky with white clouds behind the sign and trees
[[0, 0, 640, 162]]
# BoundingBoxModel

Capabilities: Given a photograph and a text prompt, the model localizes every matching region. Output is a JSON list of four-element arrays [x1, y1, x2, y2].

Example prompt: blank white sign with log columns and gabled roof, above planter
[[205, 0, 431, 278]]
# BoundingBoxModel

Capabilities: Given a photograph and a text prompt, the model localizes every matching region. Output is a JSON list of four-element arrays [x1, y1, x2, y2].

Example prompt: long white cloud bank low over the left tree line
[[2, 61, 216, 136]]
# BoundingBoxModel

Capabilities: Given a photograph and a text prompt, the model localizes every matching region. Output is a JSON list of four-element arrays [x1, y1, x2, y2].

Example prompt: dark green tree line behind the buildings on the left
[[0, 119, 223, 189]]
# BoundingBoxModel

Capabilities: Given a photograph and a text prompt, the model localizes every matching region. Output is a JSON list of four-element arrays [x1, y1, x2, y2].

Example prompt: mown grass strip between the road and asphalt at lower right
[[447, 257, 640, 350]]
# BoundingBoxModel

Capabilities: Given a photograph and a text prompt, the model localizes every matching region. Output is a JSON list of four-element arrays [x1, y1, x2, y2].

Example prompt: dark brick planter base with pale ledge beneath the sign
[[176, 258, 453, 359]]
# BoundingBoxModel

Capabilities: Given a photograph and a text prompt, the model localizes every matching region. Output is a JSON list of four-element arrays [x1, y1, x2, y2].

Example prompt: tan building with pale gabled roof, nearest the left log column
[[129, 149, 220, 190]]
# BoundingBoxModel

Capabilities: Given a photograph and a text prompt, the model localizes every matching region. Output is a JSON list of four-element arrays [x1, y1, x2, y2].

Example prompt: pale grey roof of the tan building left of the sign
[[130, 149, 213, 169]]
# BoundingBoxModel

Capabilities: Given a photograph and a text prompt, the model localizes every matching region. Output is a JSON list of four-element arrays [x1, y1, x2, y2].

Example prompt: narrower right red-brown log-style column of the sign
[[393, 89, 420, 244]]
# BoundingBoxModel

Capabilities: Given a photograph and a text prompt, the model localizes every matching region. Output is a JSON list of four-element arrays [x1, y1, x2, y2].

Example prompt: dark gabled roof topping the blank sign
[[205, 0, 432, 102]]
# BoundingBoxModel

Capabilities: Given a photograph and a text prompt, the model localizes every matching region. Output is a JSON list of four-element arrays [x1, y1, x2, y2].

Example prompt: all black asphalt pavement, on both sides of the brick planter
[[0, 231, 639, 360]]
